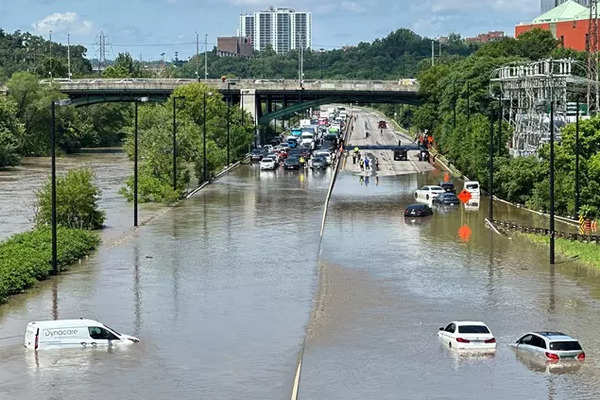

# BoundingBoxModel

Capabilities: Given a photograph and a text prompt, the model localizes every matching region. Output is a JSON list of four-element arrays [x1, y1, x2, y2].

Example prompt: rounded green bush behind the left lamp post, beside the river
[[35, 169, 104, 229]]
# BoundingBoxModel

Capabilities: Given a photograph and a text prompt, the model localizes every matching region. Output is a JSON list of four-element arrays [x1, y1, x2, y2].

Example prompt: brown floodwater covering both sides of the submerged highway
[[0, 126, 600, 399]]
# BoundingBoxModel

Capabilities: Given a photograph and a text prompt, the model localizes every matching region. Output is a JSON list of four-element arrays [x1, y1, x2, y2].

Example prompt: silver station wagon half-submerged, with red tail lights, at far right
[[512, 331, 585, 363]]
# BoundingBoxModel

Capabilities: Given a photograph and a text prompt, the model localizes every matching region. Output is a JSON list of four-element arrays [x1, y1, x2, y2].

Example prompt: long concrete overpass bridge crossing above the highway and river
[[42, 78, 420, 125]]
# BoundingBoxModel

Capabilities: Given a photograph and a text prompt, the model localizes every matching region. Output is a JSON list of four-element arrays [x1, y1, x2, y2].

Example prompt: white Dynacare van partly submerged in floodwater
[[24, 319, 140, 350]]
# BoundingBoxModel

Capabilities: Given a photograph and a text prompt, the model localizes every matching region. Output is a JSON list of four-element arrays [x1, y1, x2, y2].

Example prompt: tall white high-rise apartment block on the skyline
[[240, 8, 312, 54]]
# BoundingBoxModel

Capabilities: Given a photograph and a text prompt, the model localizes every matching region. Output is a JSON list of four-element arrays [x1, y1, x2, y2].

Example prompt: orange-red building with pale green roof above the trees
[[515, 0, 590, 51]]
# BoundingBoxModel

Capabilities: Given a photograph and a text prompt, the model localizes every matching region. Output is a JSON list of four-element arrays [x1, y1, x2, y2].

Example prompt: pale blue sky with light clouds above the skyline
[[0, 0, 540, 60]]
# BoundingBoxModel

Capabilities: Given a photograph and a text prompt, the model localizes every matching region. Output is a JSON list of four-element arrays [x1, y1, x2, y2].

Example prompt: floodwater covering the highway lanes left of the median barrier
[[0, 166, 330, 399]]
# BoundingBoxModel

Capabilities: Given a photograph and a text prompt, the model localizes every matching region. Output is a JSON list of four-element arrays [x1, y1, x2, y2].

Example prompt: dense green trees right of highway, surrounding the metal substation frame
[[383, 30, 600, 217]]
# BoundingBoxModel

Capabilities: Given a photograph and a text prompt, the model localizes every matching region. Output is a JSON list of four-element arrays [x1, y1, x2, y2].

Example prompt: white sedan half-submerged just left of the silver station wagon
[[438, 321, 496, 351]]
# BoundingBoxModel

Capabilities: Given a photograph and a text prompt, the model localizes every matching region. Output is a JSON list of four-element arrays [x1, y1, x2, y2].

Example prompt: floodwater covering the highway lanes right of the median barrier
[[301, 174, 600, 399]]
